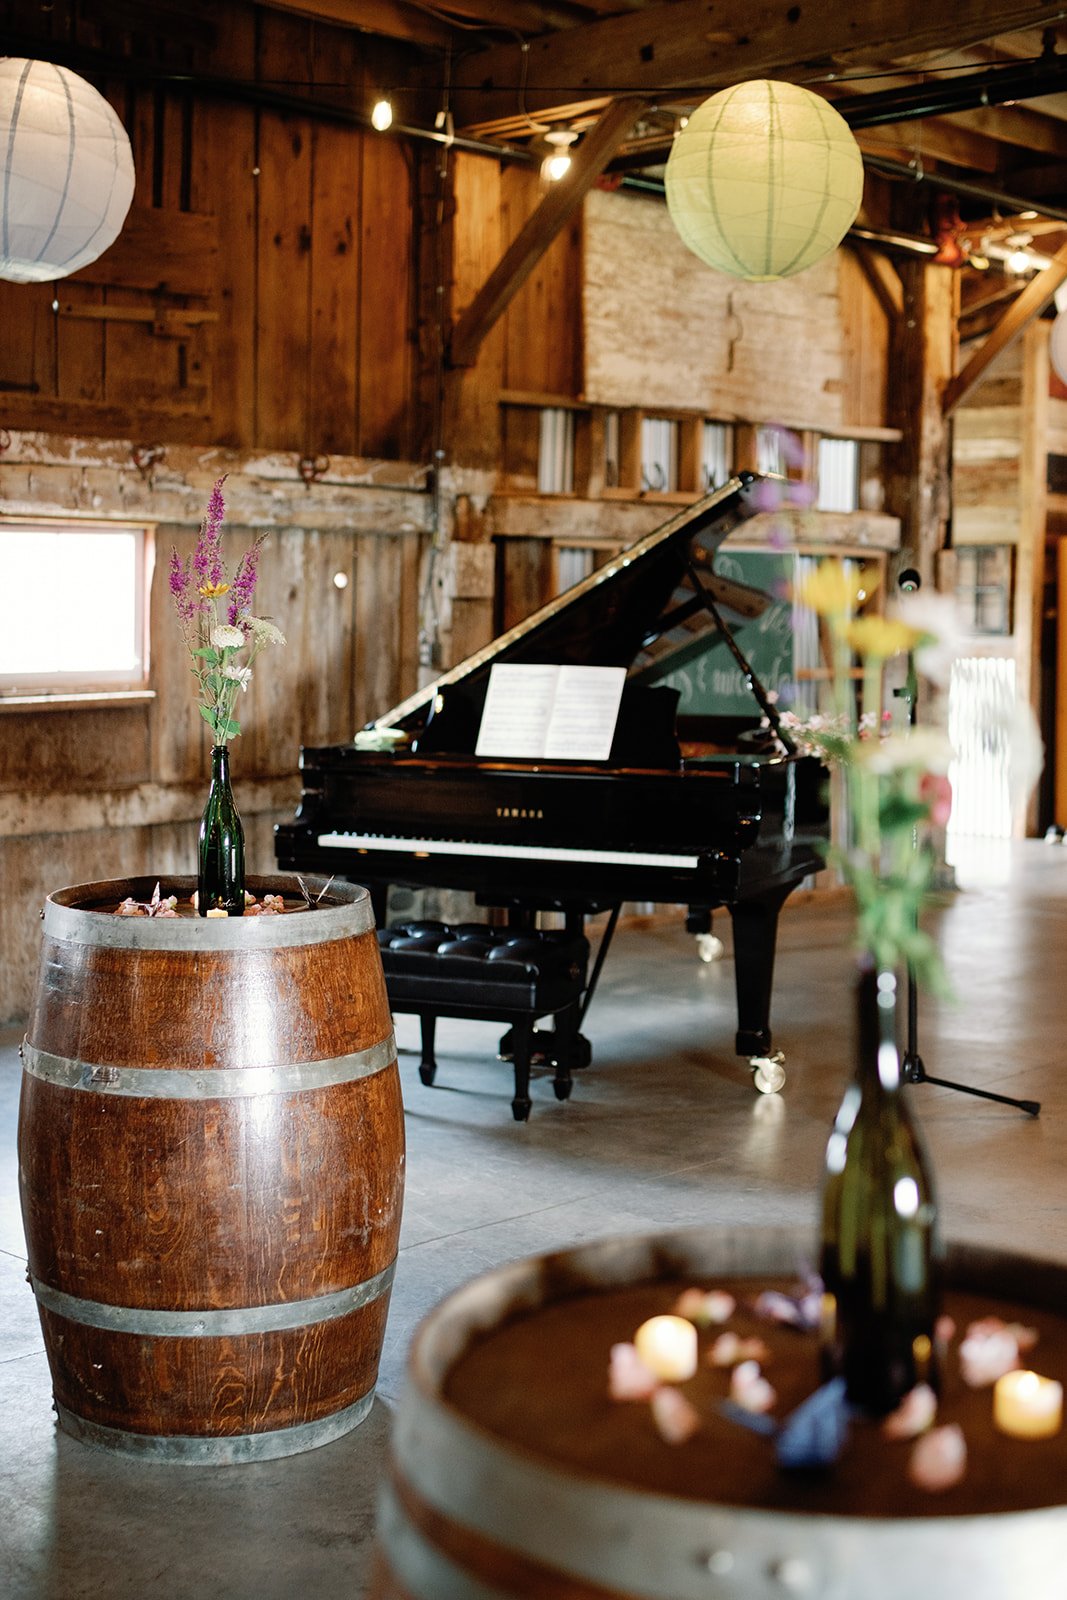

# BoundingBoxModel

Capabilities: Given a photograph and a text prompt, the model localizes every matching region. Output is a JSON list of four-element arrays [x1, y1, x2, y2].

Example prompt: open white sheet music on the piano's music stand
[[475, 662, 625, 762]]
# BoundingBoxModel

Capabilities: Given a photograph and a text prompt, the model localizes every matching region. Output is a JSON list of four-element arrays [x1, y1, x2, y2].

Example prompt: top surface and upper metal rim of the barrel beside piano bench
[[43, 874, 374, 952]]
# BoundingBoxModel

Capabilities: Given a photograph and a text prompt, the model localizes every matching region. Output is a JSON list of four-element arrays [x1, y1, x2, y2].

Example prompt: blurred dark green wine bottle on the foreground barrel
[[821, 968, 941, 1416]]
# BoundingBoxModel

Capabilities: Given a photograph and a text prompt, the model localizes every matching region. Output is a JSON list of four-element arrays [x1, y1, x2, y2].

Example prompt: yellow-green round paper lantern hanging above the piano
[[665, 78, 864, 282]]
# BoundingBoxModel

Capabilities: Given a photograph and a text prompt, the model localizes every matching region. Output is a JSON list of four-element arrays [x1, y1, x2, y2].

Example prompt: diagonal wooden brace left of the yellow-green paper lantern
[[450, 99, 645, 366]]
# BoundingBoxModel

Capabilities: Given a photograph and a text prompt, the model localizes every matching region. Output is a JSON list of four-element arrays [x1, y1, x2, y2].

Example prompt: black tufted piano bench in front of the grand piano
[[378, 922, 590, 1122]]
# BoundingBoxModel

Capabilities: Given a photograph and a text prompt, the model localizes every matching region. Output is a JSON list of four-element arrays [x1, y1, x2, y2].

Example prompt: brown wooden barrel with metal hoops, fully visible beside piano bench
[[18, 877, 405, 1464]]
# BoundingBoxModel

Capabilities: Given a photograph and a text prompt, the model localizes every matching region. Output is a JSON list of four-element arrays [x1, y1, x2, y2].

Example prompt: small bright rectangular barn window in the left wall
[[0, 517, 152, 701]]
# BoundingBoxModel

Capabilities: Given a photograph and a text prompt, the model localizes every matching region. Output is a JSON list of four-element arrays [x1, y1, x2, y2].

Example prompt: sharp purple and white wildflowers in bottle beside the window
[[170, 477, 285, 749]]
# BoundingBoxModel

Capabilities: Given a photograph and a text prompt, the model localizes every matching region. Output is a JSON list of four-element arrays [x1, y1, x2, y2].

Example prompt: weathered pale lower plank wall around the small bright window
[[0, 434, 429, 1019]]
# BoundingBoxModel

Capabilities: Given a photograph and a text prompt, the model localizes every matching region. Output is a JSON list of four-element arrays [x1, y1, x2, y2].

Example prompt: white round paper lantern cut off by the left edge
[[0, 56, 133, 283]]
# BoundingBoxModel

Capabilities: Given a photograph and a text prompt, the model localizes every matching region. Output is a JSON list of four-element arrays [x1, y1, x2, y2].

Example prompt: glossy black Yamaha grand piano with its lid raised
[[275, 474, 829, 1088]]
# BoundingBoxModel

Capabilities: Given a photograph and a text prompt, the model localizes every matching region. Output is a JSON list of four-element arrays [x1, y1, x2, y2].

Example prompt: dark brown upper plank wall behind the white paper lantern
[[0, 0, 424, 459]]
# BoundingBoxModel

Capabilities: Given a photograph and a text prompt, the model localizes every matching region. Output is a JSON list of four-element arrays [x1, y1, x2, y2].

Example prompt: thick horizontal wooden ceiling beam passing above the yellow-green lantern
[[453, 0, 1062, 126]]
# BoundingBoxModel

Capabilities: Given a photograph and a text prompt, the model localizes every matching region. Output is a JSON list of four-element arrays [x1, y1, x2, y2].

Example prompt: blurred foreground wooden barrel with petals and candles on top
[[371, 1227, 1067, 1600]]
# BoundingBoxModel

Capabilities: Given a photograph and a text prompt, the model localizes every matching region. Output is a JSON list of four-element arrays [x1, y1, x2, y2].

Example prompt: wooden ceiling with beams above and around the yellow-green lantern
[[261, 0, 1067, 331]]
